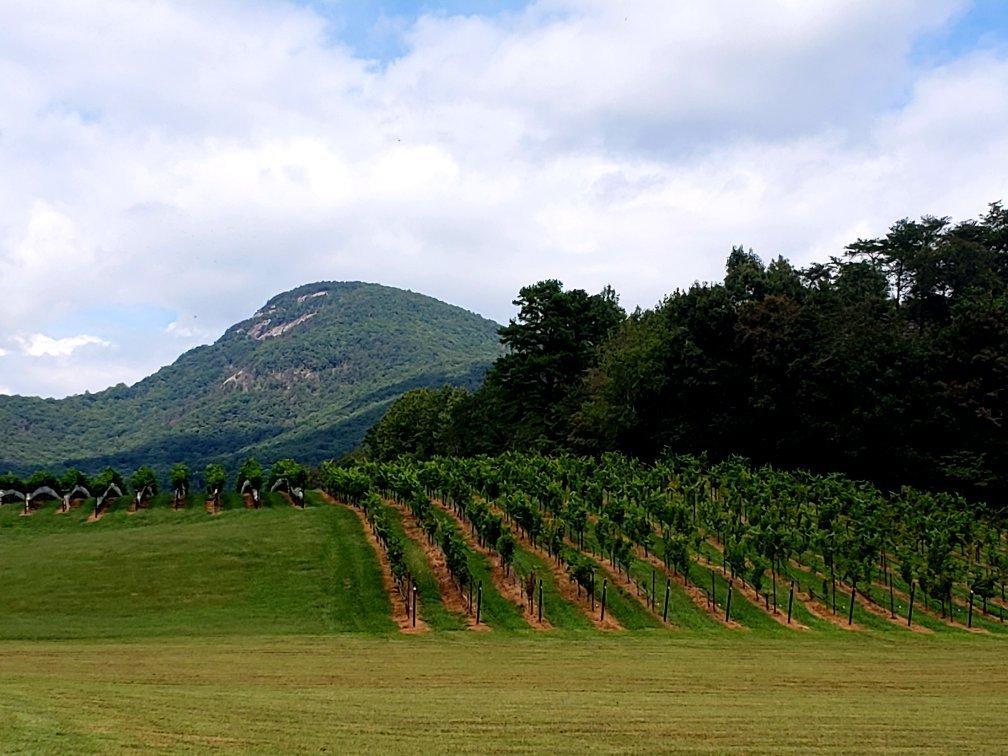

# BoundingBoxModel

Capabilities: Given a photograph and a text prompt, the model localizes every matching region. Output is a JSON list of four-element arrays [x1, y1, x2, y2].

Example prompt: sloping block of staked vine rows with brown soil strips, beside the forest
[[319, 455, 1008, 633]]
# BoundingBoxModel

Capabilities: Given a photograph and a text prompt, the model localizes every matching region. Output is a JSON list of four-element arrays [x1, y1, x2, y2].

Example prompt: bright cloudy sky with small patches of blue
[[0, 0, 1008, 397]]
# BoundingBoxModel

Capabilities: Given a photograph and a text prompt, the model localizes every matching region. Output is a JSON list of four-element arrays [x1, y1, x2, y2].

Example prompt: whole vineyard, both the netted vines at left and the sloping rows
[[0, 454, 1008, 634]]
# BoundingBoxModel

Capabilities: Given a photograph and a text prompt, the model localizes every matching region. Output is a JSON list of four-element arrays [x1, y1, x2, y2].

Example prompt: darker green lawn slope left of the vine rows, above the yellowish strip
[[0, 497, 394, 638]]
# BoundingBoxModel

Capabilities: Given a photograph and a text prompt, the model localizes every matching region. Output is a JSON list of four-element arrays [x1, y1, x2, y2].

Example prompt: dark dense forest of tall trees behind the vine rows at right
[[365, 203, 1008, 502]]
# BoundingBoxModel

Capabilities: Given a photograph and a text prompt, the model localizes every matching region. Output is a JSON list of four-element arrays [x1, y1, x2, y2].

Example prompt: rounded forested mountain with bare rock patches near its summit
[[0, 281, 501, 473]]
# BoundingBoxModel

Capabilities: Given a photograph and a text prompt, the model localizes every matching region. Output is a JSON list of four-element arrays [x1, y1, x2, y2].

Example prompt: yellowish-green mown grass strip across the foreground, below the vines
[[0, 633, 1008, 753]]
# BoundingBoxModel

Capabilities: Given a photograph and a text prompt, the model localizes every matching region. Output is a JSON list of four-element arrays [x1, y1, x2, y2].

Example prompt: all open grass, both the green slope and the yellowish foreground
[[0, 495, 1008, 753]]
